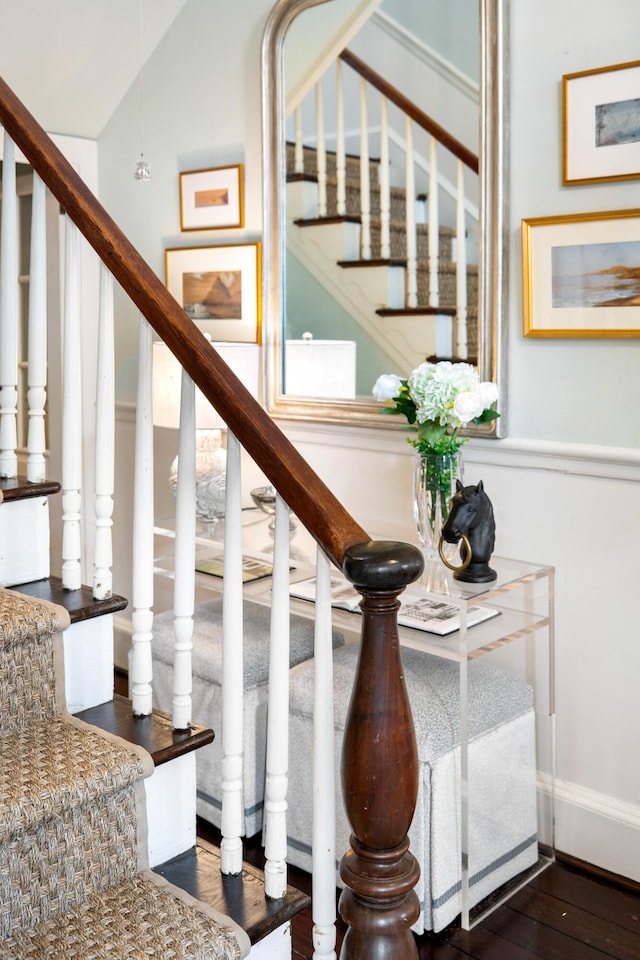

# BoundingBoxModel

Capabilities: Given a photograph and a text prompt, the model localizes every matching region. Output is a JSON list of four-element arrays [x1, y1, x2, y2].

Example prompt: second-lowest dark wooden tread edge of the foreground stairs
[[75, 694, 214, 767]]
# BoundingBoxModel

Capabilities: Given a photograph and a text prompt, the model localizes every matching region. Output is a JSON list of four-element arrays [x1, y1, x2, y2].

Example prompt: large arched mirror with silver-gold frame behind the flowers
[[262, 0, 508, 436]]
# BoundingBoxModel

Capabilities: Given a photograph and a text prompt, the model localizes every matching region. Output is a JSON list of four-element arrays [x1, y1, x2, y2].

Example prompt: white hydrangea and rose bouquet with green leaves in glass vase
[[373, 360, 499, 454]]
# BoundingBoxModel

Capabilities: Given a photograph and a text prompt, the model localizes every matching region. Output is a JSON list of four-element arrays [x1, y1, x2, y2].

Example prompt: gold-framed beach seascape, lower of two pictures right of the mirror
[[522, 210, 640, 337]]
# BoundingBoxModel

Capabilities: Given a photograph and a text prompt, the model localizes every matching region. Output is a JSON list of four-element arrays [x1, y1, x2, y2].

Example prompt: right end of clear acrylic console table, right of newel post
[[390, 557, 555, 929]]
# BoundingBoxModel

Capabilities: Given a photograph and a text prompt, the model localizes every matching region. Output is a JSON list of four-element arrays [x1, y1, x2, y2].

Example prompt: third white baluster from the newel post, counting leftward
[[220, 430, 244, 874]]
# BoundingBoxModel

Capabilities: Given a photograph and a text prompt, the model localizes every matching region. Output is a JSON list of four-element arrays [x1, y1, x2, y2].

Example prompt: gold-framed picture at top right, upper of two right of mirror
[[562, 60, 640, 186]]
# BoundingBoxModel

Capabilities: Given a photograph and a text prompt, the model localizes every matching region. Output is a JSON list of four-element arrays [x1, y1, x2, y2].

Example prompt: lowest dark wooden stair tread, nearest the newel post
[[154, 838, 311, 944]]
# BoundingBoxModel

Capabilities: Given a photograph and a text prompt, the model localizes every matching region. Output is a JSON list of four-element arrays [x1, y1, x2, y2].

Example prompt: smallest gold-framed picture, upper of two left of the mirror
[[180, 163, 244, 230]]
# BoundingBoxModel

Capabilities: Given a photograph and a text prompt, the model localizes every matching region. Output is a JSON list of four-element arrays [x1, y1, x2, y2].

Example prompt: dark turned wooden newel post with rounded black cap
[[340, 541, 423, 960]]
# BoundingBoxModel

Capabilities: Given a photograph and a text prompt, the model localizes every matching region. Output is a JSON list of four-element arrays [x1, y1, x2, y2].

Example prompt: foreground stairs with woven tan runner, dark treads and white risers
[[0, 477, 308, 960]]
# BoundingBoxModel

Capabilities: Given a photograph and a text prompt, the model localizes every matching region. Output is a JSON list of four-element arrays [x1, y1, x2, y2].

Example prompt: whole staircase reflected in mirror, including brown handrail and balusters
[[286, 50, 478, 372]]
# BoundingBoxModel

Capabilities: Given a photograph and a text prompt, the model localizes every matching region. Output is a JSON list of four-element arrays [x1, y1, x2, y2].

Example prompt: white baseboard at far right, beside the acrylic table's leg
[[545, 780, 640, 881]]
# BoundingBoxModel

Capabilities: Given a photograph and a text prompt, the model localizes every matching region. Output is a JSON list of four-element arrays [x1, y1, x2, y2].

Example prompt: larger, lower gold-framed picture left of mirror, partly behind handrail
[[165, 243, 261, 343]]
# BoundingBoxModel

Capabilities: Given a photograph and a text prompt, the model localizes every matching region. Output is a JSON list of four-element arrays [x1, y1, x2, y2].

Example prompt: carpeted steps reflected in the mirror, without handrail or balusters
[[286, 144, 478, 370]]
